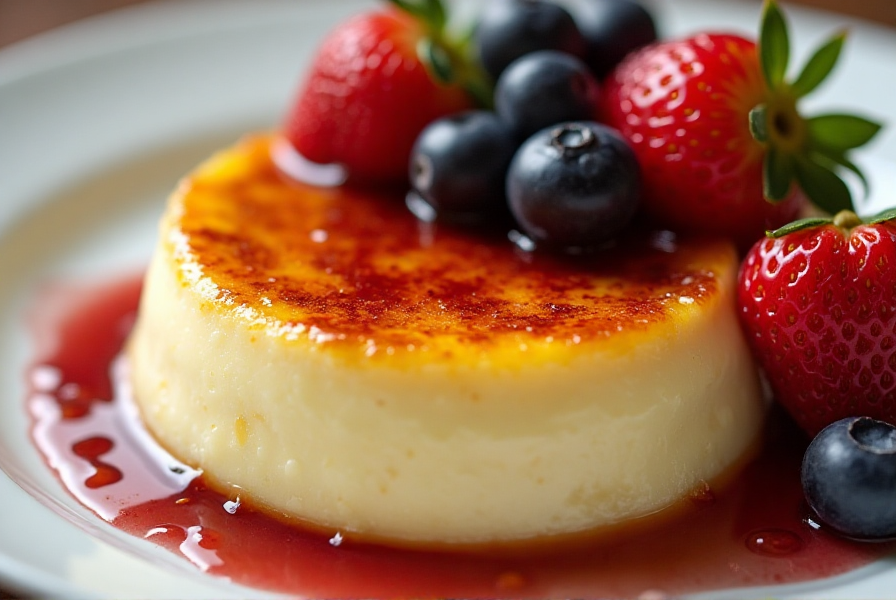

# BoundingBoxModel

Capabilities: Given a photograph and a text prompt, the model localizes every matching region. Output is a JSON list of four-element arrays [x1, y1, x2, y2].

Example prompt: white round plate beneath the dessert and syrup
[[0, 0, 896, 598]]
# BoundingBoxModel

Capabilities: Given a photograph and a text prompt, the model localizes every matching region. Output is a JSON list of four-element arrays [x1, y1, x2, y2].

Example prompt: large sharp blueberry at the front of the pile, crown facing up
[[507, 121, 641, 248]]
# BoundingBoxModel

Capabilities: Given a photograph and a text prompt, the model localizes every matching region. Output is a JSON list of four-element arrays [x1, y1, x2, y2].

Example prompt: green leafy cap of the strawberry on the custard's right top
[[750, 0, 881, 214]]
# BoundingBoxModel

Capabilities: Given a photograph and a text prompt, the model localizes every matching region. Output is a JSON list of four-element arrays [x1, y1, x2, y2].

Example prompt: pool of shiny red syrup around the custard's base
[[28, 277, 894, 598]]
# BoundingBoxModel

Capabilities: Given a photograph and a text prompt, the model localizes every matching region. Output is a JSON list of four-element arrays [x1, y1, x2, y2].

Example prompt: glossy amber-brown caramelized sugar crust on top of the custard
[[167, 136, 736, 363]]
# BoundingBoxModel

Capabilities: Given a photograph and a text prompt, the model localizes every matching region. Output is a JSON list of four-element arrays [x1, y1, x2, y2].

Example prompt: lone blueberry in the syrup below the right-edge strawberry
[[802, 417, 896, 539]]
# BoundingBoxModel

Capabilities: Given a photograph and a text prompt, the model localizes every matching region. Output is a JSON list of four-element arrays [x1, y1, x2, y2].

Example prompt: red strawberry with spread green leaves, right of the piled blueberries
[[602, 1, 880, 248]]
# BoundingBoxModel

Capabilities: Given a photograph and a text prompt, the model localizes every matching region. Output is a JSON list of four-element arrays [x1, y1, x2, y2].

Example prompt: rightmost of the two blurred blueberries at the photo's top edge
[[571, 0, 657, 78]]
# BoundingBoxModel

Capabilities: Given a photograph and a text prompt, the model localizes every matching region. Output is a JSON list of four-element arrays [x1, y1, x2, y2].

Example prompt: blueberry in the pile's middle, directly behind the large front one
[[495, 50, 599, 139]]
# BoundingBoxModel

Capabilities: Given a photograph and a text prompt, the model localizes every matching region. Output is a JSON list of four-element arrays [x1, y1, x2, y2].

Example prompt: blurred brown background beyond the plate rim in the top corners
[[0, 0, 896, 46]]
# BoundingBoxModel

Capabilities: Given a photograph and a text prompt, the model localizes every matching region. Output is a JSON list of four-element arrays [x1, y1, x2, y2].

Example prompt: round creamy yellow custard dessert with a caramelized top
[[128, 135, 765, 545]]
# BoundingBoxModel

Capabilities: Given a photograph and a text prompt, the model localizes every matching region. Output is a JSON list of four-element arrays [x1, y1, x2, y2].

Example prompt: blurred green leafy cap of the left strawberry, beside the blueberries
[[389, 0, 492, 107]]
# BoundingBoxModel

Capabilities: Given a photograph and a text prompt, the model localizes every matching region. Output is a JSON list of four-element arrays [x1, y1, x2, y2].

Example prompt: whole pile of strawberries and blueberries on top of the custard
[[284, 0, 879, 251]]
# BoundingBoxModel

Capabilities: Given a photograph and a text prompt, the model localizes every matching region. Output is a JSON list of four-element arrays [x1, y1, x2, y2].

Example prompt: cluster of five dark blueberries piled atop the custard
[[410, 0, 656, 249]]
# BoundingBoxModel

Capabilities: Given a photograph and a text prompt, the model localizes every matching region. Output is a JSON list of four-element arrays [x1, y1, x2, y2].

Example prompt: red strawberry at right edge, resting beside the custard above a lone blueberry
[[737, 209, 896, 435]]
